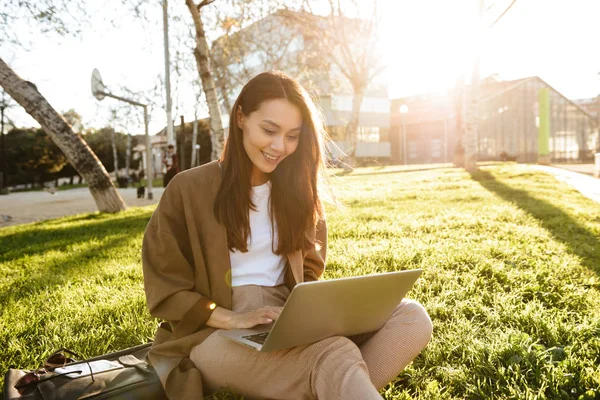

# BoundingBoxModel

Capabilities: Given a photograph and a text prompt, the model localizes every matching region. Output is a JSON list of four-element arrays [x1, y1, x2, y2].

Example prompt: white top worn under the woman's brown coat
[[229, 182, 285, 287]]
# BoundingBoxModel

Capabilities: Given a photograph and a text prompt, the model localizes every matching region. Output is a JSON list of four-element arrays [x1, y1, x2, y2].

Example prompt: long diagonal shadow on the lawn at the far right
[[471, 170, 600, 275]]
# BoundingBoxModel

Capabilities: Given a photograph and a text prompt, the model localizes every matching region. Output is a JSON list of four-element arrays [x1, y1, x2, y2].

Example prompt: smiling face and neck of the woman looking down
[[236, 99, 302, 186]]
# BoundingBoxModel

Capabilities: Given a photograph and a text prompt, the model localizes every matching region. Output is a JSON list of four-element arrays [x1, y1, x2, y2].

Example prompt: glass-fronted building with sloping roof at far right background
[[477, 77, 599, 162]]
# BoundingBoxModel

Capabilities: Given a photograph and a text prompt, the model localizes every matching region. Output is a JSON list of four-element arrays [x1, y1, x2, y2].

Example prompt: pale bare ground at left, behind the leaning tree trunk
[[0, 188, 164, 228]]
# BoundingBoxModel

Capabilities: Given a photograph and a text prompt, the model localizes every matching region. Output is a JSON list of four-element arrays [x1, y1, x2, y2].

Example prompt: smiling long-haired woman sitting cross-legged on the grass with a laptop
[[143, 72, 432, 400]]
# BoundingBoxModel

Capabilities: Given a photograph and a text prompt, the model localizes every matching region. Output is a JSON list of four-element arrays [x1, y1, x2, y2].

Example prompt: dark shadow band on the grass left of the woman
[[0, 212, 151, 304]]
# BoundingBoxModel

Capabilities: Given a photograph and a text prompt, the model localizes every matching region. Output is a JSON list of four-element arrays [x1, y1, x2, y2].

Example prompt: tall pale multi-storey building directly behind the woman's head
[[211, 11, 391, 160]]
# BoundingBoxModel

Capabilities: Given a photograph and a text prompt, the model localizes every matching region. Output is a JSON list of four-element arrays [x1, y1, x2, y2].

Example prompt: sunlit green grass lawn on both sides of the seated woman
[[0, 164, 600, 399]]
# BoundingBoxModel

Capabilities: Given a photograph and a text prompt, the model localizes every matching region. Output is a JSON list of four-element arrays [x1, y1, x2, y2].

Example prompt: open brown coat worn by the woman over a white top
[[142, 161, 327, 400]]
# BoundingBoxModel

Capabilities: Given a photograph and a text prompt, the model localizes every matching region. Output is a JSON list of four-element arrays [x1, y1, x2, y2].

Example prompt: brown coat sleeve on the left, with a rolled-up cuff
[[142, 176, 215, 336]]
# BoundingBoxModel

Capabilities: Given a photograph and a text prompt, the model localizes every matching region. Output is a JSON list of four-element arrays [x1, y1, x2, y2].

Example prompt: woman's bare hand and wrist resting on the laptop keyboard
[[206, 306, 283, 330]]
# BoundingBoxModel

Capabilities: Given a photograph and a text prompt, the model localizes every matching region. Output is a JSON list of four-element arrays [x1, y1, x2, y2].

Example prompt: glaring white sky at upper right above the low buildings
[[383, 0, 600, 99]]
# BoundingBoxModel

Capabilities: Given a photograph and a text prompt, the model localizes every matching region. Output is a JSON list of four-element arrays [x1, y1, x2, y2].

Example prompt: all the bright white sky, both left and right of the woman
[[0, 0, 600, 134]]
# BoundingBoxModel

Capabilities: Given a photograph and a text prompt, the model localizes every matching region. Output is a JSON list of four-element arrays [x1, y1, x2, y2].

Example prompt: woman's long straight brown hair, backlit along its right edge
[[214, 71, 326, 255]]
